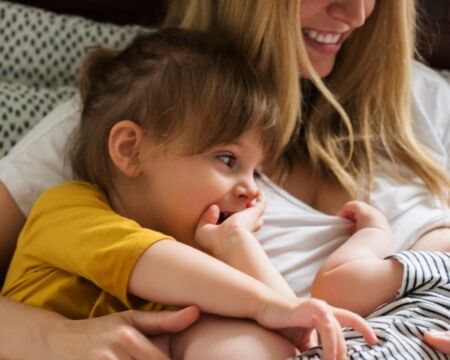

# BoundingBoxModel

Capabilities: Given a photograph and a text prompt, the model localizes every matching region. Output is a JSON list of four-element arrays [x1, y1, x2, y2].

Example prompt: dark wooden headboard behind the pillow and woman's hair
[[6, 0, 450, 69]]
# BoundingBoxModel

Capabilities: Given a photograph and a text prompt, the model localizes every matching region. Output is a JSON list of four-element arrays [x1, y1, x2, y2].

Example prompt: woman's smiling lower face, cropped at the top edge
[[300, 0, 376, 77]]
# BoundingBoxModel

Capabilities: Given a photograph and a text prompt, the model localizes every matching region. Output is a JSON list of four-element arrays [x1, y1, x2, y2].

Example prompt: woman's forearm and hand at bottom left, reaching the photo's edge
[[0, 299, 199, 360]]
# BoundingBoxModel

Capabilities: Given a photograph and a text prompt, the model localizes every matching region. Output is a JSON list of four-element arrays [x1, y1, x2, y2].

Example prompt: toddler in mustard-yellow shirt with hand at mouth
[[2, 29, 376, 359]]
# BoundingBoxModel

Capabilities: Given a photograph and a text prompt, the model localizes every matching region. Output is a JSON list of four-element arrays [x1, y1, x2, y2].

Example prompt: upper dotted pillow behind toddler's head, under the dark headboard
[[0, 1, 143, 87]]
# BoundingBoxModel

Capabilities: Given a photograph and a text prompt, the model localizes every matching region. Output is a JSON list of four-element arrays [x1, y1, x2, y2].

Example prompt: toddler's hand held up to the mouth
[[195, 192, 266, 258]]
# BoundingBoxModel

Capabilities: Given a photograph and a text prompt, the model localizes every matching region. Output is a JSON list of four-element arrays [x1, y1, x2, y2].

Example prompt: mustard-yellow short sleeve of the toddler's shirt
[[13, 182, 170, 303]]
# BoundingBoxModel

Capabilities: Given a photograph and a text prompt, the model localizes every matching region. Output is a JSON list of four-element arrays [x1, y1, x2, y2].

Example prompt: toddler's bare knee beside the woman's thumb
[[171, 315, 296, 360]]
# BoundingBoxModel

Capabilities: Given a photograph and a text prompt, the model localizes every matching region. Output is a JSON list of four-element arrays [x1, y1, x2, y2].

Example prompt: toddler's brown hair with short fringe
[[71, 29, 282, 192]]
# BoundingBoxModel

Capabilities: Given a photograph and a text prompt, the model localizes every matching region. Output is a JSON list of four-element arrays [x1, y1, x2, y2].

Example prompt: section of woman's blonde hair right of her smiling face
[[305, 0, 450, 199]]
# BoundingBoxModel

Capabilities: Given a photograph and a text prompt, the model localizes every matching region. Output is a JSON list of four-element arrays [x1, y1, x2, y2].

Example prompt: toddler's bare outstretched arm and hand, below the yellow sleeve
[[128, 236, 377, 358]]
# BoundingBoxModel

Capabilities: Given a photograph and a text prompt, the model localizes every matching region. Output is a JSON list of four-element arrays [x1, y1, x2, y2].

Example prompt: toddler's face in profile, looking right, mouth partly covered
[[130, 130, 264, 245]]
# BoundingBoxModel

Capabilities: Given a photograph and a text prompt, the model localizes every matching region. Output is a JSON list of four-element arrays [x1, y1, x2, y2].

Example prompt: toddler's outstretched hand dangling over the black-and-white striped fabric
[[256, 299, 378, 359]]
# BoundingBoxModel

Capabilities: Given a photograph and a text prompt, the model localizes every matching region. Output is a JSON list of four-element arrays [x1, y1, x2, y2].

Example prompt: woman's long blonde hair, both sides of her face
[[167, 0, 450, 199]]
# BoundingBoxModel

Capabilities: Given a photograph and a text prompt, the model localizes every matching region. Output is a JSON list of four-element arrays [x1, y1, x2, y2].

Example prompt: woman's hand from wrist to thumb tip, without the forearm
[[48, 307, 199, 360]]
